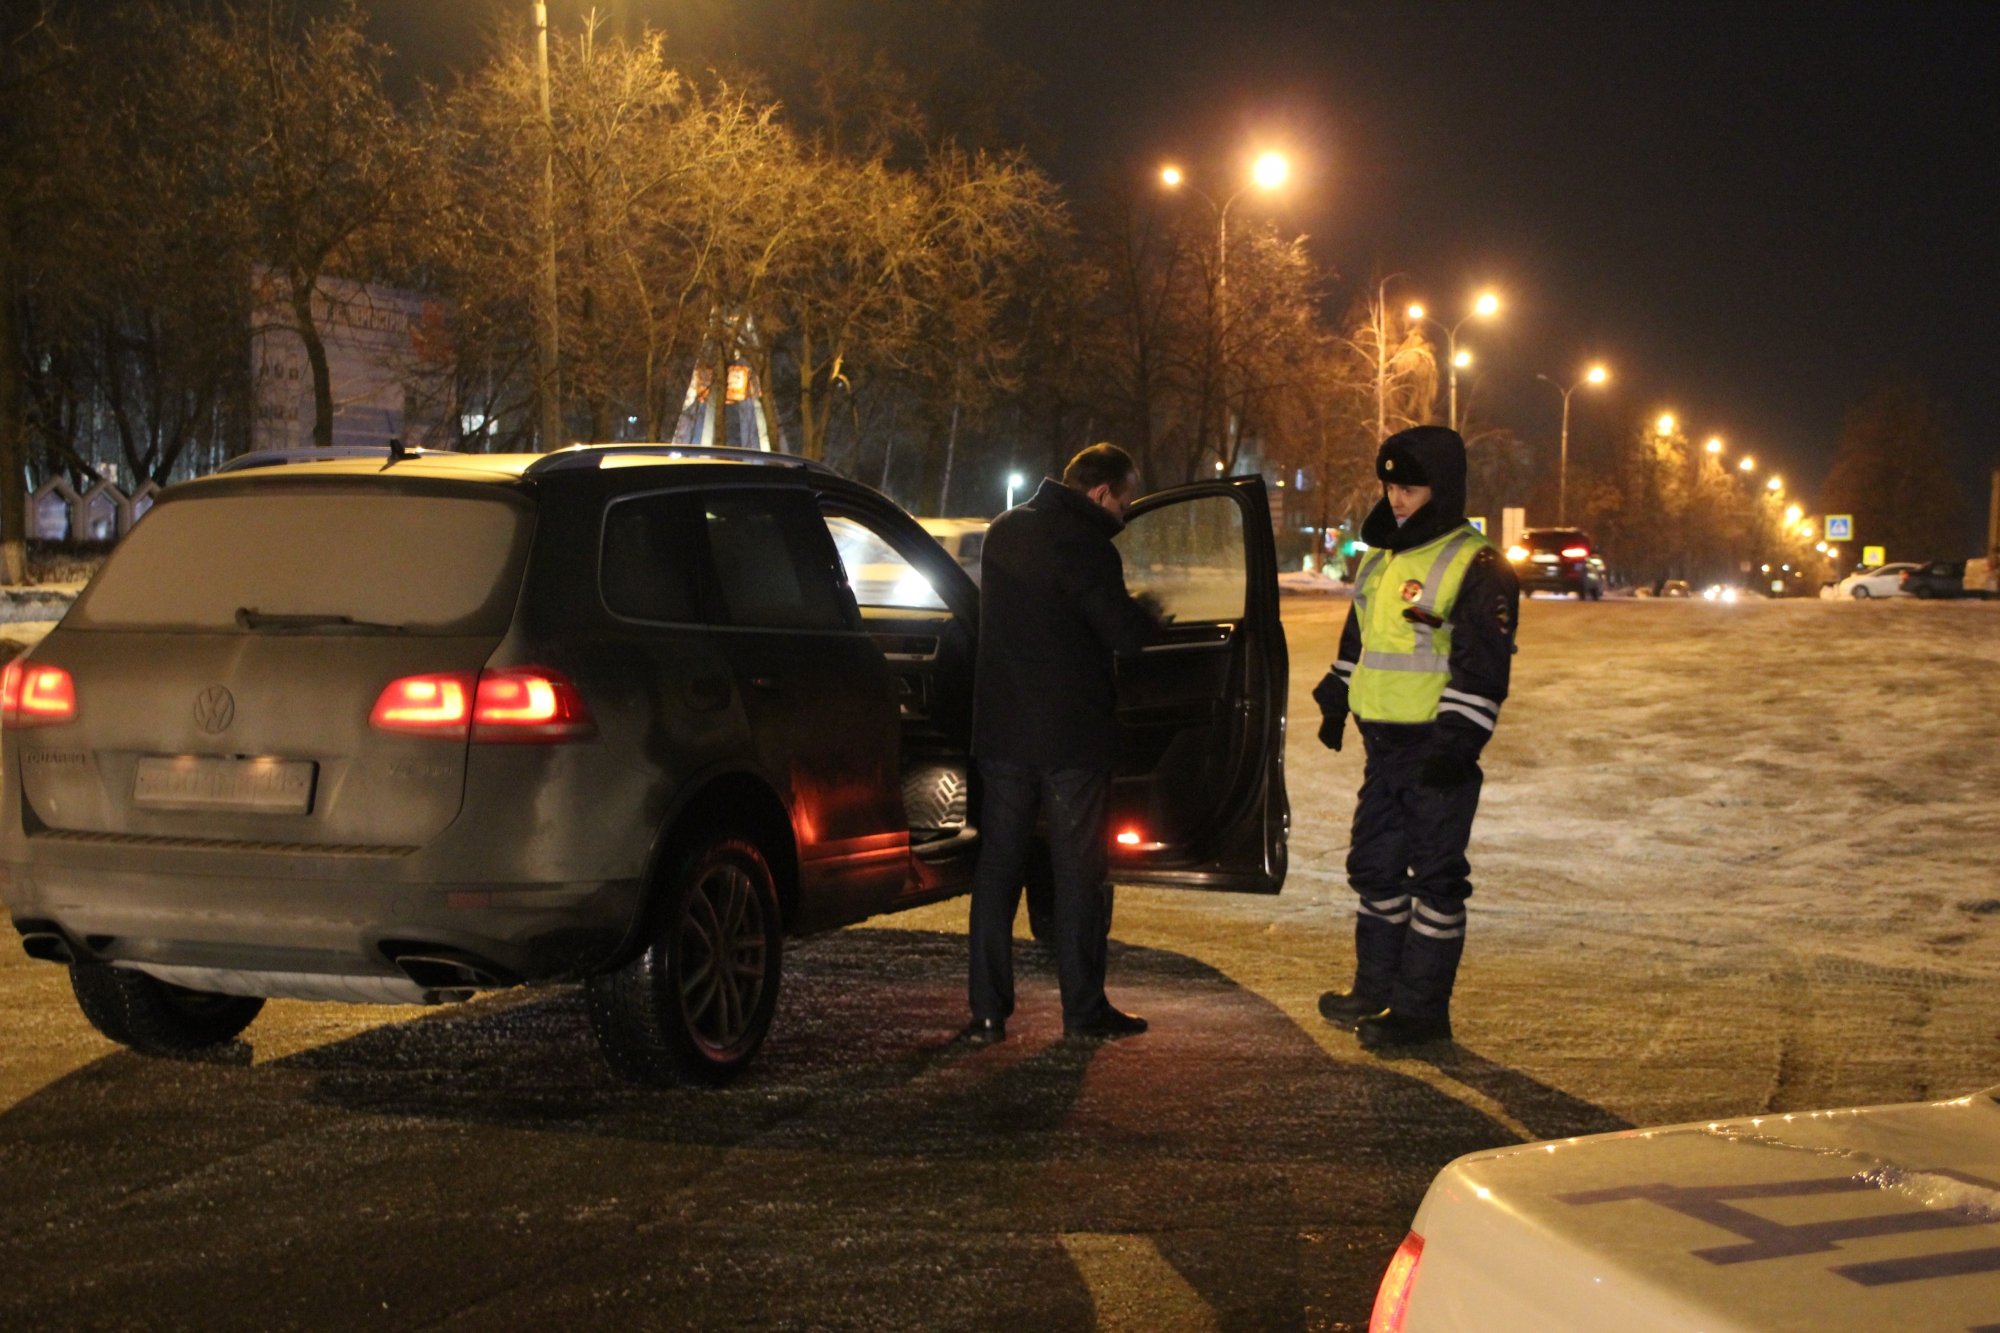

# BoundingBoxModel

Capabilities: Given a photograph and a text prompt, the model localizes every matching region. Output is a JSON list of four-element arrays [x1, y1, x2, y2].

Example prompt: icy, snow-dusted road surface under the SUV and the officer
[[0, 598, 2000, 1329]]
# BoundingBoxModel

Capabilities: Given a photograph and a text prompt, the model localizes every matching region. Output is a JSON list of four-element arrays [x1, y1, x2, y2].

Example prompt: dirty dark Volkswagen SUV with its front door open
[[0, 446, 1286, 1083]]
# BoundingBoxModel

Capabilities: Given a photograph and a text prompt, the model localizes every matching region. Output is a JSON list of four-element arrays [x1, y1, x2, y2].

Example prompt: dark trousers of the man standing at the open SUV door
[[970, 759, 1112, 1027]]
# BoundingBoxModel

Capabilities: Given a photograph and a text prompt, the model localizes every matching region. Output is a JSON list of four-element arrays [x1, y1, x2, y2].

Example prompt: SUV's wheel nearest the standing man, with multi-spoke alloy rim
[[584, 837, 784, 1087]]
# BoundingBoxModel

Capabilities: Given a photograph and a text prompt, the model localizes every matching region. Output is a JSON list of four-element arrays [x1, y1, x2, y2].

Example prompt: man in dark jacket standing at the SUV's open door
[[966, 444, 1154, 1043]]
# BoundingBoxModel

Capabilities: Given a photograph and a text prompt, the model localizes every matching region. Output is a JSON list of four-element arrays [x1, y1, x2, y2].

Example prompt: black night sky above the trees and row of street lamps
[[370, 0, 2000, 536]]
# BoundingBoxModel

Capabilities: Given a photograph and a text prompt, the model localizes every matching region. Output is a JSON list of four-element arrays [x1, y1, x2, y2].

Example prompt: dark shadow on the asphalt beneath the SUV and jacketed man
[[0, 929, 1624, 1329]]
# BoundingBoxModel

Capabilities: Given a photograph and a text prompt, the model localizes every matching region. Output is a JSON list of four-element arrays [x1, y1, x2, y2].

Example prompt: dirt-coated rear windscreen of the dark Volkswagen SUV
[[66, 488, 530, 634]]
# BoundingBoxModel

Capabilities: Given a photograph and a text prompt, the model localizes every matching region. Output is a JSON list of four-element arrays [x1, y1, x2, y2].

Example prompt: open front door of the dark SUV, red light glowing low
[[1110, 476, 1290, 893]]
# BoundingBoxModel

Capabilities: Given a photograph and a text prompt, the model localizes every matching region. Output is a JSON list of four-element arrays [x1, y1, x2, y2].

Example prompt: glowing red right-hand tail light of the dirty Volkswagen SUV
[[368, 667, 594, 743]]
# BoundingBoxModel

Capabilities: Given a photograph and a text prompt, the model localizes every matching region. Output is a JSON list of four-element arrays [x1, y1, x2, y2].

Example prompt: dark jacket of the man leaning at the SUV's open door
[[972, 476, 1156, 769]]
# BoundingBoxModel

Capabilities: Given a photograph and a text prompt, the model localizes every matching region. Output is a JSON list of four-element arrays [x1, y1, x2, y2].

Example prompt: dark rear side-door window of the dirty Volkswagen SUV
[[702, 486, 860, 630]]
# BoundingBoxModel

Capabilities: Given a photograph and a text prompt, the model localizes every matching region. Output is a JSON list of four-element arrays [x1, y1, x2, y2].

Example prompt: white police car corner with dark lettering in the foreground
[[1368, 1087, 2000, 1333]]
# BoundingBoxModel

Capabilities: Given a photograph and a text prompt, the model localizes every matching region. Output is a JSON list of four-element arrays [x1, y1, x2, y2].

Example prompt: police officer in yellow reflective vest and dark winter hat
[[1312, 426, 1520, 1049]]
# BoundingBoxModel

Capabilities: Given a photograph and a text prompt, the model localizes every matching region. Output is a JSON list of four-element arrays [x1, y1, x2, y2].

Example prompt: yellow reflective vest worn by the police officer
[[1348, 524, 1492, 723]]
